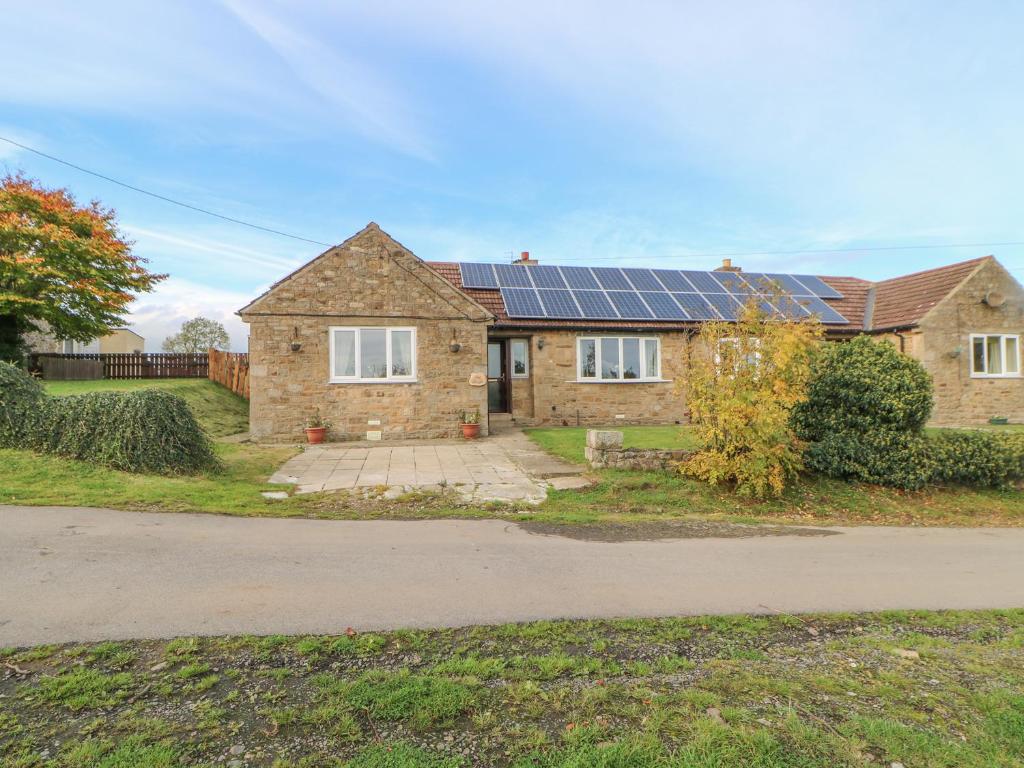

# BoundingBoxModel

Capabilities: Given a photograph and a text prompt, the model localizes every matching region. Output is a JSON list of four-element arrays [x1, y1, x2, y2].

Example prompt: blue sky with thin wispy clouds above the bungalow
[[0, 0, 1024, 349]]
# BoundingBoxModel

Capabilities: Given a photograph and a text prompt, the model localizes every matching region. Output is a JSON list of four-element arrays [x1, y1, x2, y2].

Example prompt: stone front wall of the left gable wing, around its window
[[240, 225, 490, 440]]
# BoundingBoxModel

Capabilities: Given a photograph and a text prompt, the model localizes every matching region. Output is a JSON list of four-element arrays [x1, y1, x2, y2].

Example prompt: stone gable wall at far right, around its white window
[[905, 260, 1024, 426]]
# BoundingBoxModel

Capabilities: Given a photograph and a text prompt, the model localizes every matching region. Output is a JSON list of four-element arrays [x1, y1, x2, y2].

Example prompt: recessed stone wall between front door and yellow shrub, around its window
[[512, 330, 689, 426]]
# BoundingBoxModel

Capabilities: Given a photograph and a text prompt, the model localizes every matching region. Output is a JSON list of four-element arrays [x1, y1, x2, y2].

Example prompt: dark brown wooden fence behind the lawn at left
[[30, 352, 210, 380]]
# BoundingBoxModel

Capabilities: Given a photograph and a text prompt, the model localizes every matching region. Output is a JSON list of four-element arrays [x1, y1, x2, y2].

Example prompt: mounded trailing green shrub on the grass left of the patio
[[34, 389, 218, 474]]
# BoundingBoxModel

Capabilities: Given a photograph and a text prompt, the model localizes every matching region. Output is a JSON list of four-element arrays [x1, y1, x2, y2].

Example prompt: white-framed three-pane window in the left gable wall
[[330, 328, 416, 384]]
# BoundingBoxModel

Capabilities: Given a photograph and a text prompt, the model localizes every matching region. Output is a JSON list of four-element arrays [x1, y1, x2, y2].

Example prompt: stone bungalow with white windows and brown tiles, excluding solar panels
[[239, 223, 1024, 439]]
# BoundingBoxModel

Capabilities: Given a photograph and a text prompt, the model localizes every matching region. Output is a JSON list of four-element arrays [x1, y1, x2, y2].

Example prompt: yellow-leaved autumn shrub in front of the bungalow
[[681, 287, 821, 498]]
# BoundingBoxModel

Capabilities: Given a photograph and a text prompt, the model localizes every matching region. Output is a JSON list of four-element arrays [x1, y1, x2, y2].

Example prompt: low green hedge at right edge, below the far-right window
[[929, 429, 1024, 487]]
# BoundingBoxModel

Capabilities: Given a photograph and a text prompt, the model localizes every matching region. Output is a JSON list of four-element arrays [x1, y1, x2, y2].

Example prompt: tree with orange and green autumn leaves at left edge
[[0, 174, 166, 360]]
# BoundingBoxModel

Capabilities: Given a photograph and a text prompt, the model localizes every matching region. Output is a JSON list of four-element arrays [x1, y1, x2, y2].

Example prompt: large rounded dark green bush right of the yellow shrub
[[794, 336, 932, 441]]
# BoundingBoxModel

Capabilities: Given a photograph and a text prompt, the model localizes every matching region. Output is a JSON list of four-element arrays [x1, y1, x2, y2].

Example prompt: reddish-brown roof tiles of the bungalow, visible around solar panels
[[427, 256, 992, 334]]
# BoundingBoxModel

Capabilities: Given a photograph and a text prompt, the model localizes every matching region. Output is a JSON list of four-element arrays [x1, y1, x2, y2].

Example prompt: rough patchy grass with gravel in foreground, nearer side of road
[[0, 610, 1024, 768]]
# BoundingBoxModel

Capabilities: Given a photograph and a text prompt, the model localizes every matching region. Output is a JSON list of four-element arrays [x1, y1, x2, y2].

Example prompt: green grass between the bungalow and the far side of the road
[[0, 391, 1024, 524]]
